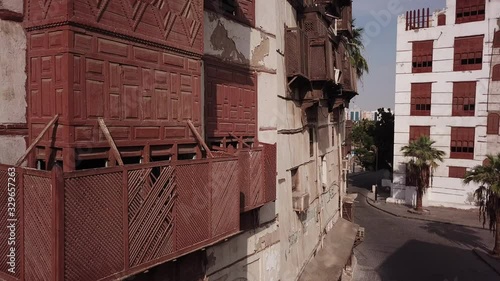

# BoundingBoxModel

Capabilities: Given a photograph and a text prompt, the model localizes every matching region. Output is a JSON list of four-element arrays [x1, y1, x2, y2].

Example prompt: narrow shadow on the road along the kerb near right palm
[[421, 222, 493, 251]]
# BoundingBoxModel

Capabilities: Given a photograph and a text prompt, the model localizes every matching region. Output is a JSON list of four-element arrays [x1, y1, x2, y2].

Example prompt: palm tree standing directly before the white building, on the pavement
[[401, 136, 445, 212]]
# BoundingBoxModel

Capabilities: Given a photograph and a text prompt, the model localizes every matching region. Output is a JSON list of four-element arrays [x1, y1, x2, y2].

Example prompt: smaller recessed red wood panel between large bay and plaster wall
[[205, 63, 257, 138]]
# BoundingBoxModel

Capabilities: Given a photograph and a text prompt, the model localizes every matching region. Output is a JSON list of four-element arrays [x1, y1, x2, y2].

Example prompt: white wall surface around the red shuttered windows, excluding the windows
[[394, 0, 499, 207]]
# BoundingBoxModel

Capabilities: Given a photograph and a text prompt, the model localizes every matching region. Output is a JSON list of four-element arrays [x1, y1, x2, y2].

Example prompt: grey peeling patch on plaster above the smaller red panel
[[210, 20, 249, 64]]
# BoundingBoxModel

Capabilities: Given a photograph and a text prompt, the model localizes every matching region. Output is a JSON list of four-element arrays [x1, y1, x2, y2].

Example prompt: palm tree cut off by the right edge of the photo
[[464, 153, 500, 257]]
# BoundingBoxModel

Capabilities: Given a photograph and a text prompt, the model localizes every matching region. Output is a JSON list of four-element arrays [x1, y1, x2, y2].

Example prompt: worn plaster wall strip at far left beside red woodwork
[[0, 0, 26, 164]]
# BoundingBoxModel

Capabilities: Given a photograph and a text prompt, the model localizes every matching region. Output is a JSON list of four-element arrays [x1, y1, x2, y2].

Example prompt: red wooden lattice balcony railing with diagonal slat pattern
[[0, 145, 276, 281]]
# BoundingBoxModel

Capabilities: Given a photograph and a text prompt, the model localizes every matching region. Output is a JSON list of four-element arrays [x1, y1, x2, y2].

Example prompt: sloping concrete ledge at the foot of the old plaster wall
[[298, 219, 359, 281]]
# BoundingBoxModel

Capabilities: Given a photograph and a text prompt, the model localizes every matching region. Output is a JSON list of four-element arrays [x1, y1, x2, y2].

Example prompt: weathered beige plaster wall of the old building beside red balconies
[[205, 0, 341, 281]]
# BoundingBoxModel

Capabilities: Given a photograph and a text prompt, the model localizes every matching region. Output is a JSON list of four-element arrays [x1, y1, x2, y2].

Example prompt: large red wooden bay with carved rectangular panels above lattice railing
[[28, 26, 201, 158]]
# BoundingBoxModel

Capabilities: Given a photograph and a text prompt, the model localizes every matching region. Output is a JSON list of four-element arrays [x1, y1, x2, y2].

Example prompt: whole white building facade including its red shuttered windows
[[388, 0, 500, 208]]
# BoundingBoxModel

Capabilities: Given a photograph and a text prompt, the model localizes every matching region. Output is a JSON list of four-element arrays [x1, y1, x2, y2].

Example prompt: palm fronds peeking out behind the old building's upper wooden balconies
[[342, 19, 369, 79]]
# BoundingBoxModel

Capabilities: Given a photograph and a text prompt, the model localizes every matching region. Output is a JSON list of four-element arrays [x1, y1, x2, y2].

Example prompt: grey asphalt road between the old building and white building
[[353, 174, 500, 281]]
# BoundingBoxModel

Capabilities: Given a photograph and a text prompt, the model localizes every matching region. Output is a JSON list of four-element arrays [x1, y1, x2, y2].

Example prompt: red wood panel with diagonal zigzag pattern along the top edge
[[23, 0, 203, 54]]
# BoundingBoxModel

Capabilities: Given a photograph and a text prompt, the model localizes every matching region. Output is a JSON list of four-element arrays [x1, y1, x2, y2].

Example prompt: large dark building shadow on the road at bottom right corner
[[375, 240, 499, 281]]
